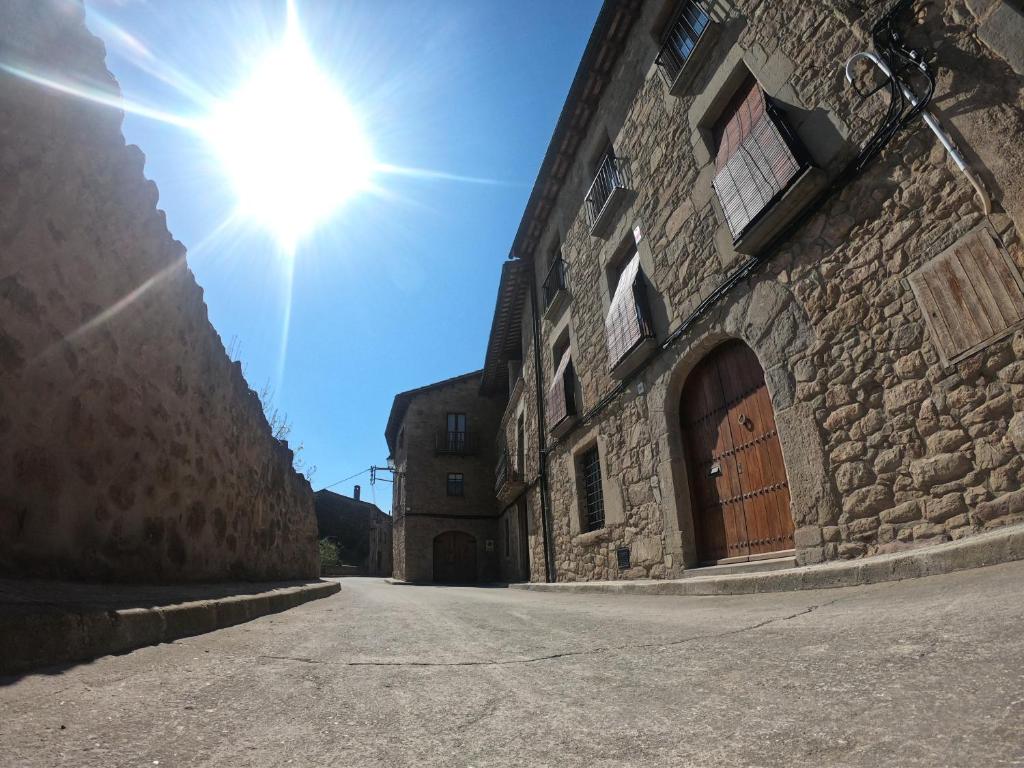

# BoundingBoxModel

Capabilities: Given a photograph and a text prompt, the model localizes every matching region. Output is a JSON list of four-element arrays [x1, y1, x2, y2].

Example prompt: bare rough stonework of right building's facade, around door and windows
[[525, 0, 1024, 580]]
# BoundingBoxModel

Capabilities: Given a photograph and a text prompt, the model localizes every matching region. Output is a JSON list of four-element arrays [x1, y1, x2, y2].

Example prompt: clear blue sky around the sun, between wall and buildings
[[86, 0, 600, 509]]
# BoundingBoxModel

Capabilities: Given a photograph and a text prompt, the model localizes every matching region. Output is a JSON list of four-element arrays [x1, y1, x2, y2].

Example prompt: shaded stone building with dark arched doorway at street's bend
[[385, 371, 526, 583]]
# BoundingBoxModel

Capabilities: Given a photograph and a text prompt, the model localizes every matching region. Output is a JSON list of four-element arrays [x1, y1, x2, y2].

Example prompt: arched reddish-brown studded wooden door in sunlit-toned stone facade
[[680, 341, 793, 562]]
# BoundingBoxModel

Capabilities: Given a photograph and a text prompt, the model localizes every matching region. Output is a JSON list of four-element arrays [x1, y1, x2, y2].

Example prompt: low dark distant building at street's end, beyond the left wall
[[313, 485, 392, 577]]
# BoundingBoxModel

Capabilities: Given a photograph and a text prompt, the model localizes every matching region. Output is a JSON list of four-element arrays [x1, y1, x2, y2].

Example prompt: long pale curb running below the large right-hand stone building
[[511, 525, 1024, 595]]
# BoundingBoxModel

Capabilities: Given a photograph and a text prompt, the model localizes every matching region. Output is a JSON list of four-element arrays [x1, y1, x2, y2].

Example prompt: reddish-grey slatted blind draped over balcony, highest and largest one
[[714, 78, 807, 239]]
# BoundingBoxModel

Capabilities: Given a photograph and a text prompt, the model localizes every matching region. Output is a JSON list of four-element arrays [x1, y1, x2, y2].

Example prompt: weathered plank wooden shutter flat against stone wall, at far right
[[908, 227, 1024, 366]]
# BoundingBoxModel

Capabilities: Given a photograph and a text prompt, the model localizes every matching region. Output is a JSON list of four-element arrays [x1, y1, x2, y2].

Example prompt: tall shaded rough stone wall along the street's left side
[[0, 0, 318, 582]]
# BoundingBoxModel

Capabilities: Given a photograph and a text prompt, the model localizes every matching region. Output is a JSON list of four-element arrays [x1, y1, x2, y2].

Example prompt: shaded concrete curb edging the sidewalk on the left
[[0, 582, 341, 675]]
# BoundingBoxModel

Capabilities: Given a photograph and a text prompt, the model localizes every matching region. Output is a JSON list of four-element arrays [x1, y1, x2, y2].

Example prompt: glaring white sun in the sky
[[203, 3, 374, 252]]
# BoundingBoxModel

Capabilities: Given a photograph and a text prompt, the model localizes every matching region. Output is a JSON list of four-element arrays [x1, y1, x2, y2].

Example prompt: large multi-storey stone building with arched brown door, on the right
[[479, 0, 1024, 581]]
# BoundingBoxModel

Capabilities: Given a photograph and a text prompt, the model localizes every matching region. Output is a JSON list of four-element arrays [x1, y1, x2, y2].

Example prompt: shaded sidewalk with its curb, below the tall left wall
[[0, 579, 340, 675]]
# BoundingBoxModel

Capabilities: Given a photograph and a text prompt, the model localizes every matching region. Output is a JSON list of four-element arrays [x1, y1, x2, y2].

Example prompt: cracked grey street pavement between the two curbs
[[0, 562, 1024, 768]]
